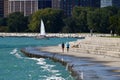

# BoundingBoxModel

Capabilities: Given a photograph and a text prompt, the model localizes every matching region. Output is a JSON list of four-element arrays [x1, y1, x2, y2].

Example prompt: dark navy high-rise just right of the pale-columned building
[[38, 0, 52, 9]]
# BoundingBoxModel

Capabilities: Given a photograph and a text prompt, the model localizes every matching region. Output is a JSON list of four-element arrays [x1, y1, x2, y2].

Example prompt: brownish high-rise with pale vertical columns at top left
[[4, 0, 38, 16]]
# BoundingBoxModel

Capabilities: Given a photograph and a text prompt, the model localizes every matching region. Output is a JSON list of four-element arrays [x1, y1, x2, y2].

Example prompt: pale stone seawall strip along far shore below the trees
[[0, 33, 111, 38]]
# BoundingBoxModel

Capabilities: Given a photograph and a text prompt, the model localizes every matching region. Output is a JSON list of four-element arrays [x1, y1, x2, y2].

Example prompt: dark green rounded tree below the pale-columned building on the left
[[8, 12, 27, 32]]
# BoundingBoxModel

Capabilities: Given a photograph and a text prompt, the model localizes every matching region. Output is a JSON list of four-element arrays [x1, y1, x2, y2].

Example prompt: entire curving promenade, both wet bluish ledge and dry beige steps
[[15, 34, 120, 80]]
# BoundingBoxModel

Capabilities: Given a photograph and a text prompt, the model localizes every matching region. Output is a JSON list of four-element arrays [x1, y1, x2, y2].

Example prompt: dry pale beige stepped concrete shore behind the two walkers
[[39, 37, 120, 67]]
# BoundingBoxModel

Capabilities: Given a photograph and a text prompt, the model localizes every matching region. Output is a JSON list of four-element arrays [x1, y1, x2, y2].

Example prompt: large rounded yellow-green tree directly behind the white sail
[[29, 8, 64, 32]]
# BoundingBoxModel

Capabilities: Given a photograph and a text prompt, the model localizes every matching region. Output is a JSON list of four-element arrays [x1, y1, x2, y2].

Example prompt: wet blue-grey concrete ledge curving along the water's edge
[[21, 47, 120, 80]]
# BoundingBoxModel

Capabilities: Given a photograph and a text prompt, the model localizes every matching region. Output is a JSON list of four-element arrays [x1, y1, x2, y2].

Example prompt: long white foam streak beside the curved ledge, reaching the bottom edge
[[28, 58, 65, 80]]
